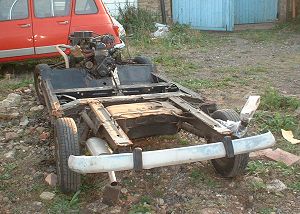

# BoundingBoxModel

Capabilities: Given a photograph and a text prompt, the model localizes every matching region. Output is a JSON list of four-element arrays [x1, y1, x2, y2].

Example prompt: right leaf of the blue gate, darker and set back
[[234, 0, 278, 24]]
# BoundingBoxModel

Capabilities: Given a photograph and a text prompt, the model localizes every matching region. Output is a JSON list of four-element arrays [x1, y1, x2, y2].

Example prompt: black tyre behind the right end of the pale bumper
[[211, 109, 249, 178]]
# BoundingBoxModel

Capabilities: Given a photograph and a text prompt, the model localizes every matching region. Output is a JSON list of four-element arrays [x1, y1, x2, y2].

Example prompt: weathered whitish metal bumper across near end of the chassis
[[68, 132, 275, 174]]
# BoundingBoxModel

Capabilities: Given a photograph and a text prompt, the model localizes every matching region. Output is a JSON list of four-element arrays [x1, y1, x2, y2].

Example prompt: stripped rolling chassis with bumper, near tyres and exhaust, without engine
[[35, 60, 275, 203]]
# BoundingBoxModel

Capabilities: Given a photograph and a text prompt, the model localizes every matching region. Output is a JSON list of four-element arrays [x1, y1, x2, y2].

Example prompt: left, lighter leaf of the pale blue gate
[[173, 0, 234, 31]]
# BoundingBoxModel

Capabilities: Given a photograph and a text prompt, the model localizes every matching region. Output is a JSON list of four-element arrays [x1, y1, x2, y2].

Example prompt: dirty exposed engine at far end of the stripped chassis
[[70, 31, 116, 79]]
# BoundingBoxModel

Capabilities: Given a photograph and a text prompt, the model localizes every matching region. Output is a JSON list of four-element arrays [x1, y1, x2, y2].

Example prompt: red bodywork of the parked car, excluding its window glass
[[0, 0, 121, 63]]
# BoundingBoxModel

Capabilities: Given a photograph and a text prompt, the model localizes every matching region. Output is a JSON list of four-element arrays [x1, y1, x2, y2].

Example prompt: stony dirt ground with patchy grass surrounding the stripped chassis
[[0, 26, 300, 214]]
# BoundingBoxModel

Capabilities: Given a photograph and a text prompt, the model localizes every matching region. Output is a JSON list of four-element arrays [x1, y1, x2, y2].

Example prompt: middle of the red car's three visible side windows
[[34, 0, 71, 18]]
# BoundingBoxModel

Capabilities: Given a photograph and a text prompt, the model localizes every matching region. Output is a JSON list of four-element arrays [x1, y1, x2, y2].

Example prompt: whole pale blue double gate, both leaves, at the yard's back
[[172, 0, 278, 31]]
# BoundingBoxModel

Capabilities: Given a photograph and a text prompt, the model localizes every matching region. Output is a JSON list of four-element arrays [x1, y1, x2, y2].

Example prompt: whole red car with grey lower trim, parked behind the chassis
[[0, 0, 121, 62]]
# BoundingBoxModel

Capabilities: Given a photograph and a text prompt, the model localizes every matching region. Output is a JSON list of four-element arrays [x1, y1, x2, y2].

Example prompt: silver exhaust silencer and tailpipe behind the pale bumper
[[86, 137, 118, 186]]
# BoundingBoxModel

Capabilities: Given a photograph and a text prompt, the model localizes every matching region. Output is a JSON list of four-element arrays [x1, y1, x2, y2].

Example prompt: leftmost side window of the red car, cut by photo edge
[[0, 0, 28, 21]]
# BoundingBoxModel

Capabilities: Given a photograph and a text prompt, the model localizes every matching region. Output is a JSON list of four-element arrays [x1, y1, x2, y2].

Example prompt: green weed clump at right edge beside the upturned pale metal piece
[[260, 88, 300, 111]]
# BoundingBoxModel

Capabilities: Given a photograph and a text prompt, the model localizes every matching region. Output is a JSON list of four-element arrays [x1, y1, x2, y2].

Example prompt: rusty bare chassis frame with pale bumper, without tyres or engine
[[41, 67, 275, 176]]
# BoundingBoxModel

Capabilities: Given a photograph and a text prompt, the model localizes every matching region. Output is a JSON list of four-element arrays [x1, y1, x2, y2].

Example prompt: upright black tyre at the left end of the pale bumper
[[54, 118, 81, 193]]
